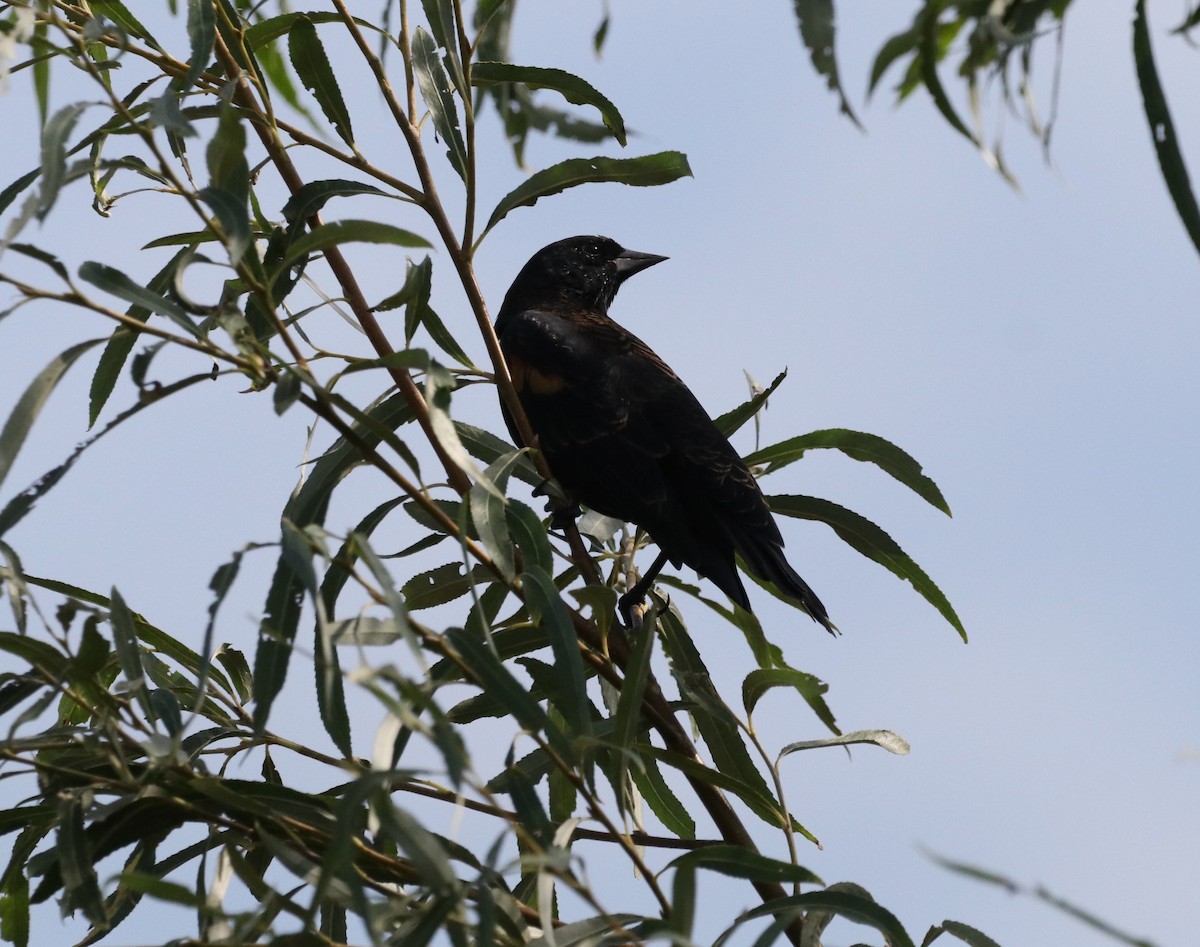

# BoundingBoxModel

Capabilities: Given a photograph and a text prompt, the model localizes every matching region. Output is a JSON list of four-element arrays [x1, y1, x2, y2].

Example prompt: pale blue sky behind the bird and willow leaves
[[0, 0, 1200, 947]]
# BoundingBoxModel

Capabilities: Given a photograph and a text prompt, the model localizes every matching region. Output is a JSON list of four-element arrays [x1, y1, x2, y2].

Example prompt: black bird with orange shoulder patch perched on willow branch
[[496, 236, 835, 631]]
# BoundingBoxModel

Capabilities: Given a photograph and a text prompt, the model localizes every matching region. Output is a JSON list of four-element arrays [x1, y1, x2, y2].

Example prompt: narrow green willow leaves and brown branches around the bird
[[0, 0, 1180, 947]]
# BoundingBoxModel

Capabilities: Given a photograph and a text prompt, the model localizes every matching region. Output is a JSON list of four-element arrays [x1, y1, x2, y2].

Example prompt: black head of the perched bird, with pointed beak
[[500, 236, 666, 314]]
